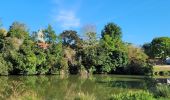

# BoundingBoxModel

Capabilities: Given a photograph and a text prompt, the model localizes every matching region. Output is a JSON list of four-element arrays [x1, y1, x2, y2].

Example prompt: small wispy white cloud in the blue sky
[[54, 10, 80, 29]]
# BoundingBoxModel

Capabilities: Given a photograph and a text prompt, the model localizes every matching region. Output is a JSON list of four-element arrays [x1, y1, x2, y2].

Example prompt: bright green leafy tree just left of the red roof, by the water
[[18, 39, 37, 75]]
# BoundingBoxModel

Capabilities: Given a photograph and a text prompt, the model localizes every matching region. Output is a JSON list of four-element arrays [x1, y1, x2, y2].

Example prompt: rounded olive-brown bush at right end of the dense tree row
[[126, 45, 152, 74]]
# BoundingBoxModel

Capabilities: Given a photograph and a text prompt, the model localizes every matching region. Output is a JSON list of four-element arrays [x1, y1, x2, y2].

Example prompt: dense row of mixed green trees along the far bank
[[0, 22, 170, 75]]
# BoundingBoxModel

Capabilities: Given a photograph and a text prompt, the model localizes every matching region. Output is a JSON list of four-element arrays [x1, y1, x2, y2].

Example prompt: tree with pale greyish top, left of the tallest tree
[[78, 32, 98, 73]]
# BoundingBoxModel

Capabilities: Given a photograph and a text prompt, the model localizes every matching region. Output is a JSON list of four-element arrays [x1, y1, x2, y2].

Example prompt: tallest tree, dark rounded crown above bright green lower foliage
[[97, 23, 128, 72]]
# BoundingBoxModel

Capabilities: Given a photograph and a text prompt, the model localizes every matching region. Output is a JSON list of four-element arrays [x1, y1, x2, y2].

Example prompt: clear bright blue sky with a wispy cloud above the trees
[[0, 0, 170, 45]]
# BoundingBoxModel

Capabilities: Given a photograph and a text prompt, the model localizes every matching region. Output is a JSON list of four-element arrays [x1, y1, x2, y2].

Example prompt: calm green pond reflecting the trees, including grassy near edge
[[0, 75, 169, 100]]
